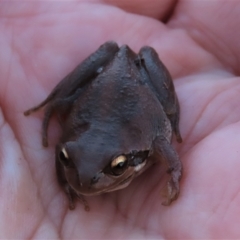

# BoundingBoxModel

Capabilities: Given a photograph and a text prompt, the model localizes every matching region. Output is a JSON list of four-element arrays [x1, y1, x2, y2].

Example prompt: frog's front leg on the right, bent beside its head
[[153, 136, 182, 205]]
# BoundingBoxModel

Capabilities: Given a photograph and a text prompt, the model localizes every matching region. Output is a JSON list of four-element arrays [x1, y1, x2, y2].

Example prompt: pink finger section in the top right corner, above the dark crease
[[171, 0, 240, 73]]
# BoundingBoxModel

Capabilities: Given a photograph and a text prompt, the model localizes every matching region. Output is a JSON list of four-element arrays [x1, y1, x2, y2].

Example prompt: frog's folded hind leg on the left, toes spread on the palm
[[24, 41, 119, 147]]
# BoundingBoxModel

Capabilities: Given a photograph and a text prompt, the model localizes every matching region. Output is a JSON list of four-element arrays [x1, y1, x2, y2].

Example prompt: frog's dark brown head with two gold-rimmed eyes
[[56, 124, 154, 195]]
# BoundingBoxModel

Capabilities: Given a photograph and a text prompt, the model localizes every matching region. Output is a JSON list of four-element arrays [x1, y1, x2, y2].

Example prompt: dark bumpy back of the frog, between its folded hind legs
[[63, 46, 172, 146]]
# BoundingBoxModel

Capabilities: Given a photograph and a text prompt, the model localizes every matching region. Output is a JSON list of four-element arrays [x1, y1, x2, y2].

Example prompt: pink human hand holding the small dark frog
[[0, 0, 240, 239]]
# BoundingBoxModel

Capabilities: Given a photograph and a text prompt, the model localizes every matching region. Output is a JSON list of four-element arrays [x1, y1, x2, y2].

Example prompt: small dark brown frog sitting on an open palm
[[24, 41, 182, 210]]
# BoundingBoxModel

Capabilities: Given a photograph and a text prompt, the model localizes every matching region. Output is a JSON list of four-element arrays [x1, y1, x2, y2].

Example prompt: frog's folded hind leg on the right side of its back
[[139, 46, 182, 142]]
